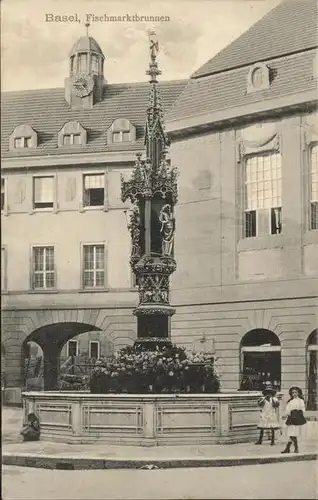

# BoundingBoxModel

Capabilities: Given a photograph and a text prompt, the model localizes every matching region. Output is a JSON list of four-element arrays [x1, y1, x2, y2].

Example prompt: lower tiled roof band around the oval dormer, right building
[[166, 50, 317, 122]]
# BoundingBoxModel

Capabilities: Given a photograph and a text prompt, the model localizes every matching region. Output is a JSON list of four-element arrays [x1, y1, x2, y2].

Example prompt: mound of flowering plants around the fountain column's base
[[90, 345, 220, 394]]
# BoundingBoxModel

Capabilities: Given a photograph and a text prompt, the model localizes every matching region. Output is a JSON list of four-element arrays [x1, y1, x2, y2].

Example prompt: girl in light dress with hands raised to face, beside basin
[[255, 385, 279, 446]]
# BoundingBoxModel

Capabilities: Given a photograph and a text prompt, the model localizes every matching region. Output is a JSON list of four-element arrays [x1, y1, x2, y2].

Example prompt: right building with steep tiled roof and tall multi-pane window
[[167, 1, 318, 408]]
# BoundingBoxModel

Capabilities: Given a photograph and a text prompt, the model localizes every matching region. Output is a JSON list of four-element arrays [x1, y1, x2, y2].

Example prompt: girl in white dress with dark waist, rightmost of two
[[282, 387, 307, 453]]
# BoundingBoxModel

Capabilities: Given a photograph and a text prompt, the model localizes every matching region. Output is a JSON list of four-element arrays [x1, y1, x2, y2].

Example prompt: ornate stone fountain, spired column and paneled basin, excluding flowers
[[22, 37, 259, 446]]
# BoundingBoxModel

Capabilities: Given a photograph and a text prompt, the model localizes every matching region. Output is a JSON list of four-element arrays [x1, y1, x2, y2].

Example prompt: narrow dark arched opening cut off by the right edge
[[306, 329, 318, 411]]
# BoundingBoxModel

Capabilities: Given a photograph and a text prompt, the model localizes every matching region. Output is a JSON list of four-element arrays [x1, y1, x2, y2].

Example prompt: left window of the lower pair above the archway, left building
[[32, 247, 55, 289]]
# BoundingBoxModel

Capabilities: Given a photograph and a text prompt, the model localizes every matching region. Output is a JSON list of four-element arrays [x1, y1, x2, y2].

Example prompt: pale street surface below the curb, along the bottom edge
[[2, 461, 317, 500]]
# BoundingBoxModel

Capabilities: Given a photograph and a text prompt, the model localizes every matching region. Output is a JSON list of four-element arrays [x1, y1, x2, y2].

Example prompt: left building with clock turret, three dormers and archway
[[1, 32, 185, 400]]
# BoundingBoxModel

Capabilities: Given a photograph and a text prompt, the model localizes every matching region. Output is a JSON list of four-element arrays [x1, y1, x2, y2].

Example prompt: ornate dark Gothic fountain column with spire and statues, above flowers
[[121, 32, 177, 349]]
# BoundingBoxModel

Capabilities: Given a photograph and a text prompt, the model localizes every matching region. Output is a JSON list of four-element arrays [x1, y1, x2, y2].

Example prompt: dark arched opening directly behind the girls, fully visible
[[240, 329, 281, 391]]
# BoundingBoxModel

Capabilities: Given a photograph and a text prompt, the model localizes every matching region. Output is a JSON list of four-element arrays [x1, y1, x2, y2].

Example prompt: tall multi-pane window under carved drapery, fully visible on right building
[[245, 153, 282, 237]]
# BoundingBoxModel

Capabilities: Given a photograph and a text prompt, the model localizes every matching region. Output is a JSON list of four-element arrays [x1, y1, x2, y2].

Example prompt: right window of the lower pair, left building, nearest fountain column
[[83, 245, 105, 288]]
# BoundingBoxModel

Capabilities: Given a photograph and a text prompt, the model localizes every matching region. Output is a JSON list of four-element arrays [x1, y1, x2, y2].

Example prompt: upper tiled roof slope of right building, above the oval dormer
[[192, 0, 318, 78]]
